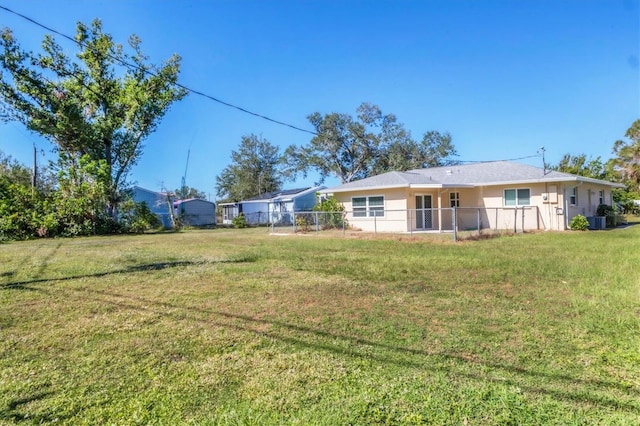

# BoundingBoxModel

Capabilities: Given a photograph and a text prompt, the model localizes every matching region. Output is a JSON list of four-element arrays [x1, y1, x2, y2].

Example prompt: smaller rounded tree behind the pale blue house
[[216, 134, 282, 201]]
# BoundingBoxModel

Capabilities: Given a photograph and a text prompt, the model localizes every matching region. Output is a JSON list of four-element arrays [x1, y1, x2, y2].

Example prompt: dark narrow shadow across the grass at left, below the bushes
[[0, 255, 257, 291]]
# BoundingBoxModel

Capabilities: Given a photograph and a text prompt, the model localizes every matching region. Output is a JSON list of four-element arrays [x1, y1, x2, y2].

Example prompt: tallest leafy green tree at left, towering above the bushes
[[0, 20, 186, 215]]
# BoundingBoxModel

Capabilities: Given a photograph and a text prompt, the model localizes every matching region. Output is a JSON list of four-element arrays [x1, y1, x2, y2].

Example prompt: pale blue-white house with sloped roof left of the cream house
[[220, 186, 325, 225]]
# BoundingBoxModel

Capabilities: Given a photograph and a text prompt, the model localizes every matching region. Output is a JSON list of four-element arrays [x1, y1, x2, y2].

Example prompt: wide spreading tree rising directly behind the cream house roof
[[283, 102, 456, 183]]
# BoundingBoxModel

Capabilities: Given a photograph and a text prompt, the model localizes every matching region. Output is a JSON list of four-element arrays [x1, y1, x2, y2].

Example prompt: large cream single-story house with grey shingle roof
[[320, 161, 622, 232]]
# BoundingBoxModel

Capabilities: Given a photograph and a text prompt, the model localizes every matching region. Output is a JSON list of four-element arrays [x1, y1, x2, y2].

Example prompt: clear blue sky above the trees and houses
[[0, 0, 640, 199]]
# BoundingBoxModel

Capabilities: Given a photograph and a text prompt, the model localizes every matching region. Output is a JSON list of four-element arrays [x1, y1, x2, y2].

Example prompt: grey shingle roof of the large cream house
[[320, 161, 621, 194]]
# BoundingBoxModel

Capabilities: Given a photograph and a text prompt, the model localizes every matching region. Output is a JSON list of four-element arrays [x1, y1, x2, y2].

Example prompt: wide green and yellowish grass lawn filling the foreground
[[0, 224, 640, 425]]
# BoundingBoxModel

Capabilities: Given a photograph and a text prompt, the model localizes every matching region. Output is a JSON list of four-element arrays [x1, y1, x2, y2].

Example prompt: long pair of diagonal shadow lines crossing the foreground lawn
[[63, 288, 640, 412]]
